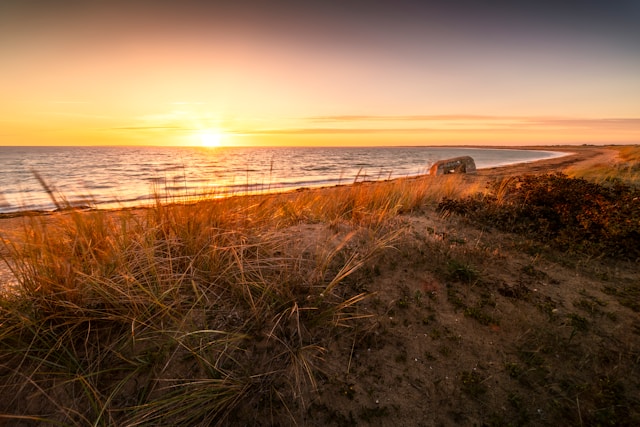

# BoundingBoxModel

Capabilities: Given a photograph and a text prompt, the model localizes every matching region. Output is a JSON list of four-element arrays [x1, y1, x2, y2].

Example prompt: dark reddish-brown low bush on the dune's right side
[[438, 173, 640, 260]]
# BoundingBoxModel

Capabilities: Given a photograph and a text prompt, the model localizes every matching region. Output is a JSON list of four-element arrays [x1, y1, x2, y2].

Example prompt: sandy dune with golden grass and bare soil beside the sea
[[0, 146, 640, 426]]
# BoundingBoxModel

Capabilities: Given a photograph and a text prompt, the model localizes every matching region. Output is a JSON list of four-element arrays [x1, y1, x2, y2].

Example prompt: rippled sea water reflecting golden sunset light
[[0, 147, 562, 213]]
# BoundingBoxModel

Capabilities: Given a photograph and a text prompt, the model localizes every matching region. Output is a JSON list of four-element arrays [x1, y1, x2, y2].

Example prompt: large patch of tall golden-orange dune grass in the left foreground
[[0, 172, 480, 425]]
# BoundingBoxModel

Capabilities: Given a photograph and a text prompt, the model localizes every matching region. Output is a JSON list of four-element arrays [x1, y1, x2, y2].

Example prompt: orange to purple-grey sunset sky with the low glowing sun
[[0, 0, 640, 147]]
